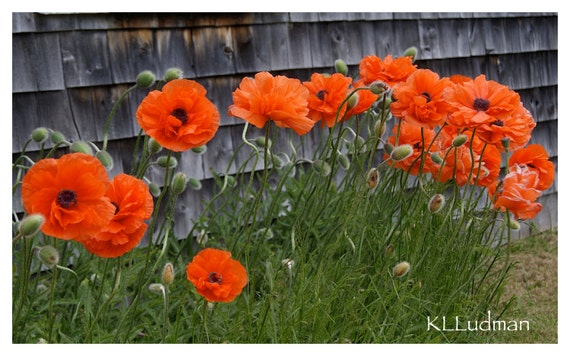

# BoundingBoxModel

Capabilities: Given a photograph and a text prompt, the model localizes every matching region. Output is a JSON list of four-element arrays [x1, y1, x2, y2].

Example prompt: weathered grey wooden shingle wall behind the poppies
[[12, 13, 558, 239]]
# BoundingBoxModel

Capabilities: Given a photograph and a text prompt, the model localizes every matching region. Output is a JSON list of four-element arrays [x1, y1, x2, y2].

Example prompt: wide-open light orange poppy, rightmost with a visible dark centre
[[444, 74, 520, 128]]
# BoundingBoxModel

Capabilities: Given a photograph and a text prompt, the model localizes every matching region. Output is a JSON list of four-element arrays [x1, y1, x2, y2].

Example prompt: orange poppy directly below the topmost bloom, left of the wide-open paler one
[[390, 69, 451, 129]]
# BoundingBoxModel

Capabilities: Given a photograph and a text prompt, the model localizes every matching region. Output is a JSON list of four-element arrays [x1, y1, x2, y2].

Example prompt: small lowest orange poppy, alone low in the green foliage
[[186, 248, 247, 302]]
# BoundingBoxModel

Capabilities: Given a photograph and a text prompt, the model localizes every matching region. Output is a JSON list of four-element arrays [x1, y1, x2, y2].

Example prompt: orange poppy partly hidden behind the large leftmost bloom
[[80, 173, 154, 258]]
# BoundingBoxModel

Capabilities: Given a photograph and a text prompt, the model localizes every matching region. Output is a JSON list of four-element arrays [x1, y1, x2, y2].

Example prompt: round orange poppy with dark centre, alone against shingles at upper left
[[136, 79, 220, 152]]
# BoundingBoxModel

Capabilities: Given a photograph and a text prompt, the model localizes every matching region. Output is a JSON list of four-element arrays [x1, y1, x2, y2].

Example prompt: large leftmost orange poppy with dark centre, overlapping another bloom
[[22, 153, 115, 240]]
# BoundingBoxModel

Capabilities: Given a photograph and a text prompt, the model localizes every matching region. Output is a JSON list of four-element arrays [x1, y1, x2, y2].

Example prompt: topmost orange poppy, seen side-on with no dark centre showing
[[359, 54, 416, 88]]
